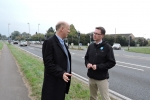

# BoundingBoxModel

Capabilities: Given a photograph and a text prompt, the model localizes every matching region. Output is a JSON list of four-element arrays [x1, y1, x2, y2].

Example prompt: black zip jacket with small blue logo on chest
[[85, 41, 116, 80]]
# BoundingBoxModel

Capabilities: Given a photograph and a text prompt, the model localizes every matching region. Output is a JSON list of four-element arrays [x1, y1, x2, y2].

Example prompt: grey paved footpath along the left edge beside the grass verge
[[0, 44, 31, 100]]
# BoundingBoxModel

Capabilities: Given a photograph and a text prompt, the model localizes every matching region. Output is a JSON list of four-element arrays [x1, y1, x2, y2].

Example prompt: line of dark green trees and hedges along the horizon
[[0, 24, 149, 46]]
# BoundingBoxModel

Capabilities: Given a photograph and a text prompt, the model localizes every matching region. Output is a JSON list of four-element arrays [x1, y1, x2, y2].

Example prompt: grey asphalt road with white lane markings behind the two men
[[14, 46, 150, 100]]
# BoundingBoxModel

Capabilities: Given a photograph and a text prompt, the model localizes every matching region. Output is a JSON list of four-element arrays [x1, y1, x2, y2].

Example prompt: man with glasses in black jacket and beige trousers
[[85, 27, 116, 100]]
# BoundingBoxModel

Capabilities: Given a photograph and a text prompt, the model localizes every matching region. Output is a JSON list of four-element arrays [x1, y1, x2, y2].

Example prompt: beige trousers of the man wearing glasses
[[89, 78, 110, 100]]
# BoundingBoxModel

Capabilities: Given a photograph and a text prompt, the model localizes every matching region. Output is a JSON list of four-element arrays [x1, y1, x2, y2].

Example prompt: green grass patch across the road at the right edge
[[125, 47, 150, 54]]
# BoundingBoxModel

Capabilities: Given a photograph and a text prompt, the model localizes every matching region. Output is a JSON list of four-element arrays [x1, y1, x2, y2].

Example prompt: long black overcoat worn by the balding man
[[41, 35, 71, 100]]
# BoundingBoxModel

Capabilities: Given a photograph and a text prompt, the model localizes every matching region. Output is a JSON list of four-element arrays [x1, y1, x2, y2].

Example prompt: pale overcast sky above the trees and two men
[[0, 0, 150, 38]]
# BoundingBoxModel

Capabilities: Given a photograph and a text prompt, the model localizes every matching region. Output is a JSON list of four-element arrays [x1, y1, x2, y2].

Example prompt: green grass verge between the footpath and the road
[[8, 45, 100, 100]]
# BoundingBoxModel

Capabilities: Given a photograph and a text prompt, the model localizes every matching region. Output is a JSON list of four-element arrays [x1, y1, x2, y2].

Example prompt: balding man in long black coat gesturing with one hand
[[41, 22, 71, 100]]
